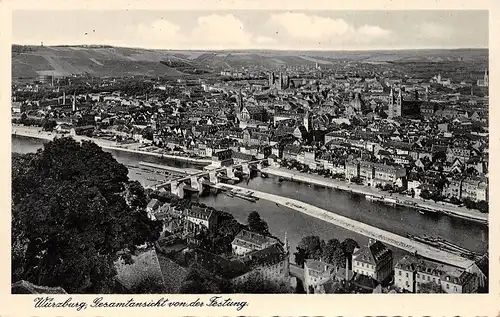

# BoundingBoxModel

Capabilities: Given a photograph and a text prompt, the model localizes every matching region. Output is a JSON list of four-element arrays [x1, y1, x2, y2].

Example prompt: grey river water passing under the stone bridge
[[12, 136, 488, 258]]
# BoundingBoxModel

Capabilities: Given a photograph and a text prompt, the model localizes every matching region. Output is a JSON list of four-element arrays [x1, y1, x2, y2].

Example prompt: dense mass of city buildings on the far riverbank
[[12, 63, 489, 205]]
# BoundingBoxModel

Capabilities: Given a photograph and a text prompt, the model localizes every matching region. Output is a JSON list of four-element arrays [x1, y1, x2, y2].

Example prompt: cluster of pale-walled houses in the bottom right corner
[[304, 241, 488, 294]]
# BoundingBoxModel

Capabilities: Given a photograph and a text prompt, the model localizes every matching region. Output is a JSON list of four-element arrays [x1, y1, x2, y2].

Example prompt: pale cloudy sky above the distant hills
[[12, 10, 488, 50]]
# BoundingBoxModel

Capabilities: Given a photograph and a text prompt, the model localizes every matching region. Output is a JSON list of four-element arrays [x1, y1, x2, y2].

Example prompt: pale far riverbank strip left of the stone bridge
[[11, 125, 212, 165]]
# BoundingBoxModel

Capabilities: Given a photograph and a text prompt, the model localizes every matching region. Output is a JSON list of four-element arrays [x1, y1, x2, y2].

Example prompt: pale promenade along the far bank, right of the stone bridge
[[262, 167, 488, 224]]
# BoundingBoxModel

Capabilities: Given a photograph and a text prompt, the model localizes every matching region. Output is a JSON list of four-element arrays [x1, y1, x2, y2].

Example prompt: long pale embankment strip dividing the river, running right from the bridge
[[224, 184, 474, 270]]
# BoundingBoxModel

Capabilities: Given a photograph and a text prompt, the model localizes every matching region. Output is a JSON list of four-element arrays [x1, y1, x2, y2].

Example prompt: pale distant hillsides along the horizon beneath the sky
[[12, 45, 488, 78]]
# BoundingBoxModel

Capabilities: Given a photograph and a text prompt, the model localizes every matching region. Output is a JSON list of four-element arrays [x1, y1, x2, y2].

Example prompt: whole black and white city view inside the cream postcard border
[[5, 3, 492, 307]]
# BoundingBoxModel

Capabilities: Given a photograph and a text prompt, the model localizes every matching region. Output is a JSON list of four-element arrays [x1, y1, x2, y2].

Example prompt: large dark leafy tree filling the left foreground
[[12, 138, 161, 293]]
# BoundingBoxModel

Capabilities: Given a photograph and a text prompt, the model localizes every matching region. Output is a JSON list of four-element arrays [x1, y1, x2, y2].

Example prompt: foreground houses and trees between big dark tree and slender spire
[[140, 198, 290, 292]]
